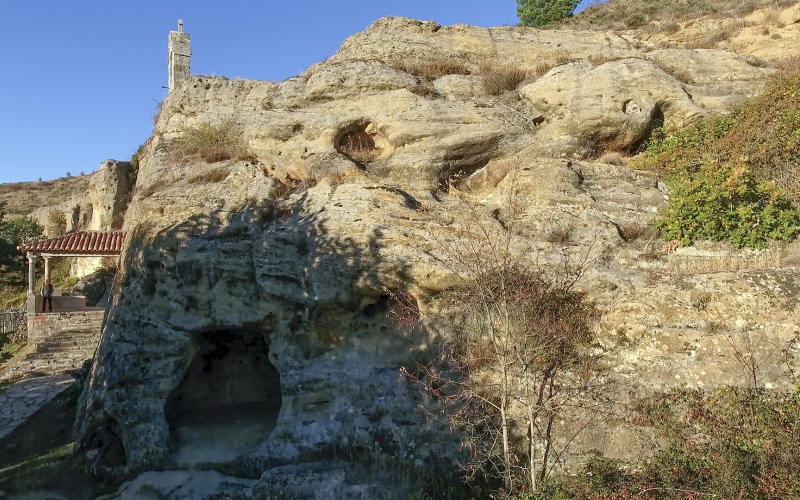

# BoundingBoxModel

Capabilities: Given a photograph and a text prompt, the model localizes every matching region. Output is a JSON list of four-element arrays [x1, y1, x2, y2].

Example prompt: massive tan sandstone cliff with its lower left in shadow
[[72, 14, 800, 497]]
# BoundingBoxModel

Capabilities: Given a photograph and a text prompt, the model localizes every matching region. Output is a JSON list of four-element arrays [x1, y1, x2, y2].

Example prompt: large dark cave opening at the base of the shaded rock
[[165, 330, 281, 464]]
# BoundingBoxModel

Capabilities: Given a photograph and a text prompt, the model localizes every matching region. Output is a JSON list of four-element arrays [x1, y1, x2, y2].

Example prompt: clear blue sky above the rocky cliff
[[0, 0, 594, 182]]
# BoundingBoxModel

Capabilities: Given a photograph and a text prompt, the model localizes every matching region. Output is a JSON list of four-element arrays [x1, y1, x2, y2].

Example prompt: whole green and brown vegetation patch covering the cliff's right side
[[631, 71, 800, 247]]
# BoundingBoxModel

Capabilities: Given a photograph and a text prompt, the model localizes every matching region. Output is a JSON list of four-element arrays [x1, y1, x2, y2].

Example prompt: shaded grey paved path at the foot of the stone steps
[[0, 374, 75, 438]]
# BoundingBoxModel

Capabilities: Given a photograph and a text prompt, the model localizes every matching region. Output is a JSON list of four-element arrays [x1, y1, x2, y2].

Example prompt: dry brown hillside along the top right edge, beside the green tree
[[554, 0, 797, 30]]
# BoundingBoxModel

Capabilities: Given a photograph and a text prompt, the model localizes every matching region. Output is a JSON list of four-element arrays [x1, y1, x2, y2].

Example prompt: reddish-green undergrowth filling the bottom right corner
[[542, 387, 800, 499]]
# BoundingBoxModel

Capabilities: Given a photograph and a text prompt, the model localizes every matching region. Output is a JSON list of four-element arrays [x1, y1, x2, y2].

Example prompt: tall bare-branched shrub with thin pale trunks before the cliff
[[401, 175, 599, 494]]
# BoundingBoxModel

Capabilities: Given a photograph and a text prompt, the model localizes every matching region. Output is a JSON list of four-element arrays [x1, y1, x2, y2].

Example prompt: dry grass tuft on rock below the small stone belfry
[[173, 120, 252, 163]]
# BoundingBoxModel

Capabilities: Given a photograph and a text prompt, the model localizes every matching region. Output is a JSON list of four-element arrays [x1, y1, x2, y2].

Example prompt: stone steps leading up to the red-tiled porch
[[0, 311, 103, 380]]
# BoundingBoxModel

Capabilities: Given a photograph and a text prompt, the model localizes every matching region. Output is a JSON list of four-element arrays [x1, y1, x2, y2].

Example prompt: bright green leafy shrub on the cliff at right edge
[[653, 163, 800, 247]]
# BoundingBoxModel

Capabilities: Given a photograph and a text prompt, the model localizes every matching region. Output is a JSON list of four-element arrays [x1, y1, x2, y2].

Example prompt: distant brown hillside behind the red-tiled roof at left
[[0, 175, 91, 217]]
